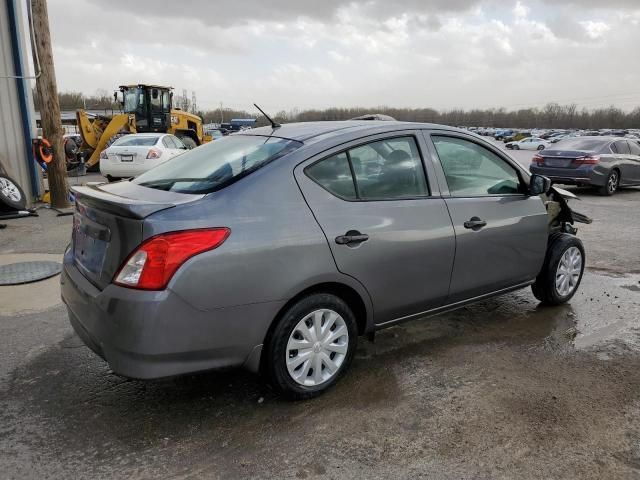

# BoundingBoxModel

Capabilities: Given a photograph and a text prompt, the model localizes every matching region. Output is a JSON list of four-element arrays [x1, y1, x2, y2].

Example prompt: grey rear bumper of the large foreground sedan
[[61, 258, 284, 379]]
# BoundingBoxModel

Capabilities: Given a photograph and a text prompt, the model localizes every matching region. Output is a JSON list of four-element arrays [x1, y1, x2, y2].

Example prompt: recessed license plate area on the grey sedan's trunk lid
[[72, 213, 110, 277]]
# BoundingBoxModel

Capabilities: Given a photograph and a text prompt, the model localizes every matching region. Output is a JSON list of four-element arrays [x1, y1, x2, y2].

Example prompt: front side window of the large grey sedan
[[431, 136, 523, 196]]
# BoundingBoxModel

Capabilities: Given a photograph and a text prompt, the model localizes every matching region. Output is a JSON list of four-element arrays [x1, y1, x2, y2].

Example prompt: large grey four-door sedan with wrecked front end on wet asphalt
[[61, 121, 585, 398]]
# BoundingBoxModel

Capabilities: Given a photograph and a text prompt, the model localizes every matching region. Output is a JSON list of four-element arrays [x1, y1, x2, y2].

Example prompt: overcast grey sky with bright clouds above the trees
[[48, 0, 640, 112]]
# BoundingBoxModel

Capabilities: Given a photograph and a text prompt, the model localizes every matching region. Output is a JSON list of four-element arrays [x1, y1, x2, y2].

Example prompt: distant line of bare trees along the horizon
[[40, 89, 640, 129]]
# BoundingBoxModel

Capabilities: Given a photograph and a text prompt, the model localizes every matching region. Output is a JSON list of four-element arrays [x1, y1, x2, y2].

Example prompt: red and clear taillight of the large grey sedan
[[113, 228, 231, 290]]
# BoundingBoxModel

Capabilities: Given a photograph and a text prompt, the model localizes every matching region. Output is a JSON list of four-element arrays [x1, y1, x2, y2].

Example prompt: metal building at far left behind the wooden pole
[[0, 0, 42, 203]]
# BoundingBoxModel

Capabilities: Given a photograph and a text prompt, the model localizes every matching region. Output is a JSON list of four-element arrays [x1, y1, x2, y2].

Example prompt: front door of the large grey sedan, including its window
[[430, 132, 548, 303]]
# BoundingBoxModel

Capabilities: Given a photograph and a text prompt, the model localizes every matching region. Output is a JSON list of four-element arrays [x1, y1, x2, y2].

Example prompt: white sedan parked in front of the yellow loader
[[100, 133, 187, 182]]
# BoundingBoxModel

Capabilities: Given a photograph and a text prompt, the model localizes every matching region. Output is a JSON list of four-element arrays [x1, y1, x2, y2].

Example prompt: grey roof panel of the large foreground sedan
[[235, 120, 469, 143]]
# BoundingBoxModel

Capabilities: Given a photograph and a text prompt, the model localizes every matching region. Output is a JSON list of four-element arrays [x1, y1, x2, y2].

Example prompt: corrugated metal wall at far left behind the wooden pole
[[0, 0, 39, 204]]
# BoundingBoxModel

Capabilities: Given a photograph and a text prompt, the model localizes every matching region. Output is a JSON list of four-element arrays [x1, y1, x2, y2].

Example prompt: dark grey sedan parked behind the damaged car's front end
[[529, 137, 640, 195]]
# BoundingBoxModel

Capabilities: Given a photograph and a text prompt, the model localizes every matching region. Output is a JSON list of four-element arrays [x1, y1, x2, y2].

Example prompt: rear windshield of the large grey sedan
[[133, 135, 301, 193]]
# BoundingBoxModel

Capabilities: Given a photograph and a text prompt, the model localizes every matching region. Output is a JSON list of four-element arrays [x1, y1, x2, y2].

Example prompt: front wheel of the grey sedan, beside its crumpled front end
[[531, 233, 585, 305]]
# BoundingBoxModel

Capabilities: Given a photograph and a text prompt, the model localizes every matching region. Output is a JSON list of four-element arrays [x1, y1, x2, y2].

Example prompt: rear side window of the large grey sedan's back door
[[305, 137, 429, 200]]
